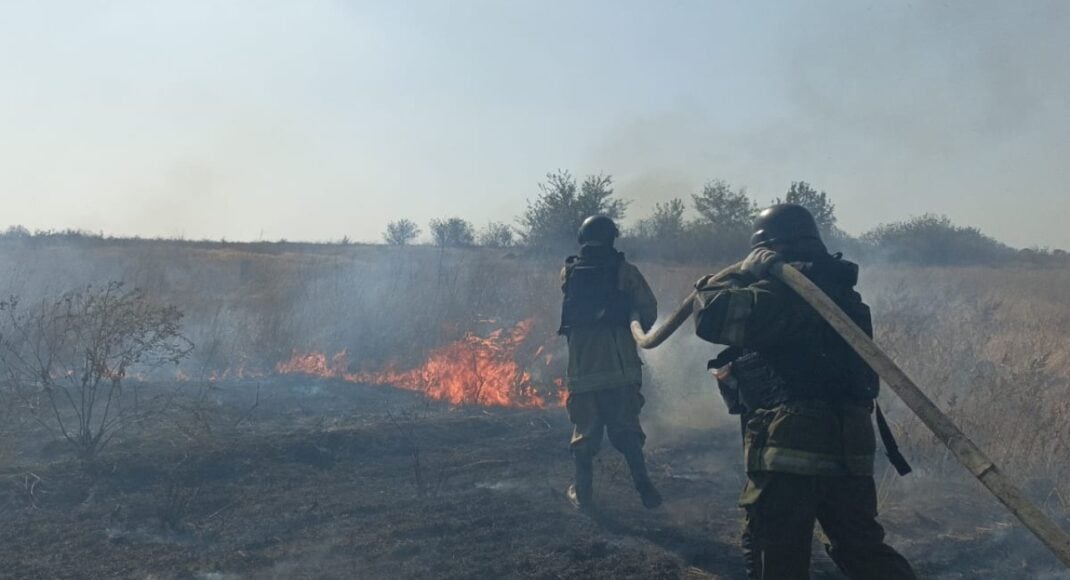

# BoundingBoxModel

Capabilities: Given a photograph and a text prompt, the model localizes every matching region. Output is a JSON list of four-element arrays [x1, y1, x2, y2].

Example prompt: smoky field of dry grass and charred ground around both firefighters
[[0, 242, 1070, 579]]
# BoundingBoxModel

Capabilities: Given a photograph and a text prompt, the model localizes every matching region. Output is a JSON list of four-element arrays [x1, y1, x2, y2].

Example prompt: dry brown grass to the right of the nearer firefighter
[[867, 269, 1070, 515]]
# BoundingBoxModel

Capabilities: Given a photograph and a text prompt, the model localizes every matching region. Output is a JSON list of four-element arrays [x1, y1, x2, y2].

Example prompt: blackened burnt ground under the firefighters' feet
[[0, 380, 1063, 579]]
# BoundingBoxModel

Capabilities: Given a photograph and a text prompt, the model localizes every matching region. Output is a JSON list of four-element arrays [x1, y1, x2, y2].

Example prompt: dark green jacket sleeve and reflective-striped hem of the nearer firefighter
[[694, 257, 876, 475]]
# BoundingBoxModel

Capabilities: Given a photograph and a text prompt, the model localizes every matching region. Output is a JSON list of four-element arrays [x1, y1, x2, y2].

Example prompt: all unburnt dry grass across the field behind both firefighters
[[0, 244, 1070, 513]]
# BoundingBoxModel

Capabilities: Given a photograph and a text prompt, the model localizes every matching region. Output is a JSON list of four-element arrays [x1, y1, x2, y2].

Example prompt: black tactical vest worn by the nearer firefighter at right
[[733, 256, 880, 409]]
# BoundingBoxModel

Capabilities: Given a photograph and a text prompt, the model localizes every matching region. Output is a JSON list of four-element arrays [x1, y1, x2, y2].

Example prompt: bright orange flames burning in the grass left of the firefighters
[[275, 319, 567, 409]]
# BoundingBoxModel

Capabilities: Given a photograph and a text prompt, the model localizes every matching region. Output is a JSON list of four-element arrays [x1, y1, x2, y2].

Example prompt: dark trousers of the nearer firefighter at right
[[740, 472, 917, 580]]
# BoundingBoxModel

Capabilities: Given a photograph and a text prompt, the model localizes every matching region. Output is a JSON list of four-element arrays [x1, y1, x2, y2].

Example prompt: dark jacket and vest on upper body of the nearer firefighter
[[700, 254, 910, 477]]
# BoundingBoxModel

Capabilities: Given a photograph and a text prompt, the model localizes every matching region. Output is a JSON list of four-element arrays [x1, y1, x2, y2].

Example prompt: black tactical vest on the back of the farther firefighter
[[557, 248, 631, 335]]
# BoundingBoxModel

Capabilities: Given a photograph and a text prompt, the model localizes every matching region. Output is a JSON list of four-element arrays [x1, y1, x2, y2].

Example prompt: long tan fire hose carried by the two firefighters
[[631, 262, 1070, 568]]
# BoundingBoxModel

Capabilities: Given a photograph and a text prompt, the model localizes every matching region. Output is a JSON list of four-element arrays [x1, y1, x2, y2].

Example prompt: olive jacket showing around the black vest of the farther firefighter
[[561, 251, 658, 393]]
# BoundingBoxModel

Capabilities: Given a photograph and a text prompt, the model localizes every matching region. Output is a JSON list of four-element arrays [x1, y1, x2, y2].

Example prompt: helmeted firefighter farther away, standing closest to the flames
[[557, 215, 661, 510]]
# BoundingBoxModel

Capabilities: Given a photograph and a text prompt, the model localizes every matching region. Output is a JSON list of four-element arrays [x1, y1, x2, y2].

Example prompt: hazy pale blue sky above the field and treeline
[[0, 0, 1070, 248]]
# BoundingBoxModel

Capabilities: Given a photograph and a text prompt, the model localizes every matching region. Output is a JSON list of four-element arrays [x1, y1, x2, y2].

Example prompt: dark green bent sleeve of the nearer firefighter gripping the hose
[[694, 273, 816, 349]]
